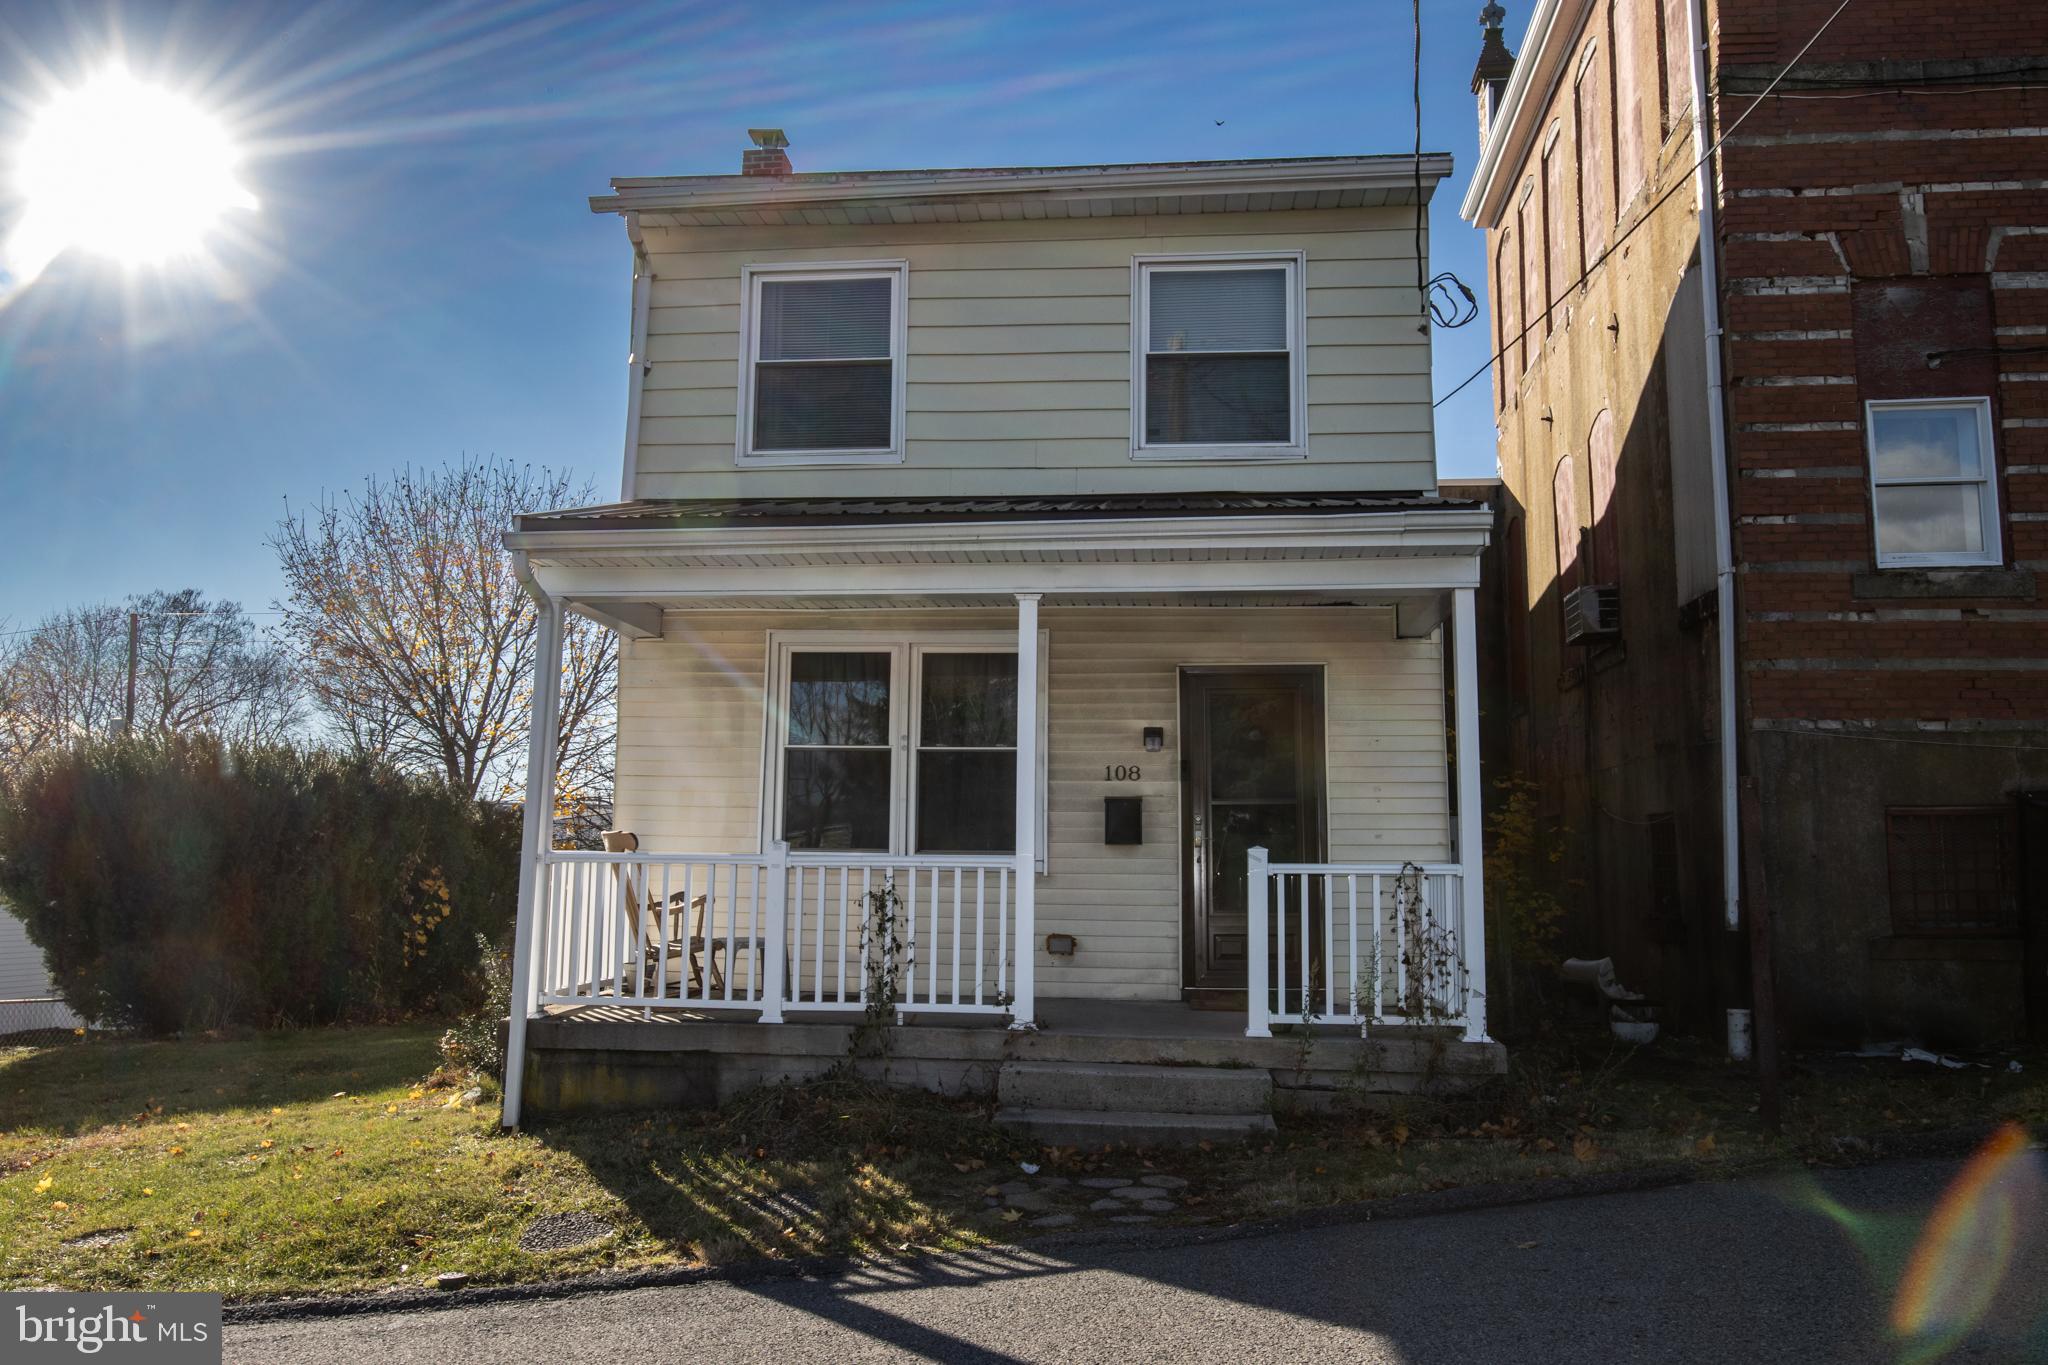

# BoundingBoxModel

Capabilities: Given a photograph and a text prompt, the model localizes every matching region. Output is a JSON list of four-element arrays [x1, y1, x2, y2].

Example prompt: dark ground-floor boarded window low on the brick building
[[1884, 806, 2019, 937]]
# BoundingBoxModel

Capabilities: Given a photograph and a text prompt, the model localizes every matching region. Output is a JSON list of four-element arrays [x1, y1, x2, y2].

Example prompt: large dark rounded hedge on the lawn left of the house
[[0, 737, 520, 1031]]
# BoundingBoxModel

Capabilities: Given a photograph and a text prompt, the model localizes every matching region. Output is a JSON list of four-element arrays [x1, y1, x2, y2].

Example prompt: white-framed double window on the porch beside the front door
[[764, 632, 1044, 866]]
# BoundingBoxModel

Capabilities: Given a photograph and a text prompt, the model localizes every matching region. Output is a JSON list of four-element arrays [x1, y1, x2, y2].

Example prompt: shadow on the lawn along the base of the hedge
[[0, 1023, 440, 1138]]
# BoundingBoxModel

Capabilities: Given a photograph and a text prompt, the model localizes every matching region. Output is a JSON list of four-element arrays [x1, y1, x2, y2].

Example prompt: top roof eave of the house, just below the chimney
[[590, 151, 1452, 213]]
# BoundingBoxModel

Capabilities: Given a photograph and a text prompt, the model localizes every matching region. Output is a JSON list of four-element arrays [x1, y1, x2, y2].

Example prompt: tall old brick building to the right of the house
[[1464, 0, 2048, 1046]]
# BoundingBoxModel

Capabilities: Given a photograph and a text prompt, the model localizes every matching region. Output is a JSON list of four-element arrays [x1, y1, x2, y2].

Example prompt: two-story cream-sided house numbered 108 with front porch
[[506, 129, 1501, 1136]]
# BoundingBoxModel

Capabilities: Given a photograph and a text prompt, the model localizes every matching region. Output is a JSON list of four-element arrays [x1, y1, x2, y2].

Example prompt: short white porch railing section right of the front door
[[1245, 849, 1485, 1038]]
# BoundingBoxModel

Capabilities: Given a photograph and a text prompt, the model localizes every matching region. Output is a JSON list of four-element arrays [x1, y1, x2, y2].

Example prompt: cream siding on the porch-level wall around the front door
[[616, 606, 1450, 1001]]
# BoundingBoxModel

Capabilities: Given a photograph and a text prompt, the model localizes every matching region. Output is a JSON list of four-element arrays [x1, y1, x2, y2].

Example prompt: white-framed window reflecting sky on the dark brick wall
[[1864, 399, 2003, 569]]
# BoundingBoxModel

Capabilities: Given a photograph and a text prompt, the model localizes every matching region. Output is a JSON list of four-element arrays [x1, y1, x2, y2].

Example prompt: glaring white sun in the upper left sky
[[6, 68, 256, 280]]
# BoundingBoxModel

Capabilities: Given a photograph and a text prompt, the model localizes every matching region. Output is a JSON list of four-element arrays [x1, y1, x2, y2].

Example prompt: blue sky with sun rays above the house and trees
[[0, 0, 1522, 628]]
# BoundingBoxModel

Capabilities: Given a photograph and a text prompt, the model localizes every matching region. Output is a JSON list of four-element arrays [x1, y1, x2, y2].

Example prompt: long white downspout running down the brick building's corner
[[1686, 0, 1743, 929]]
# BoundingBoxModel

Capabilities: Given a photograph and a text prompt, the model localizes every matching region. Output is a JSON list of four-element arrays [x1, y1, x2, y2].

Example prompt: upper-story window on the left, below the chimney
[[739, 260, 907, 465]]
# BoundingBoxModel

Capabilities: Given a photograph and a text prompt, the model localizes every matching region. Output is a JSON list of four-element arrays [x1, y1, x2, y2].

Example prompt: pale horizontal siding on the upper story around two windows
[[635, 209, 1436, 497]]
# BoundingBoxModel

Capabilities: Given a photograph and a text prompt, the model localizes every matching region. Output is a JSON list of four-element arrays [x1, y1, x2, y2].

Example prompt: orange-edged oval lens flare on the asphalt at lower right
[[1892, 1124, 2042, 1359]]
